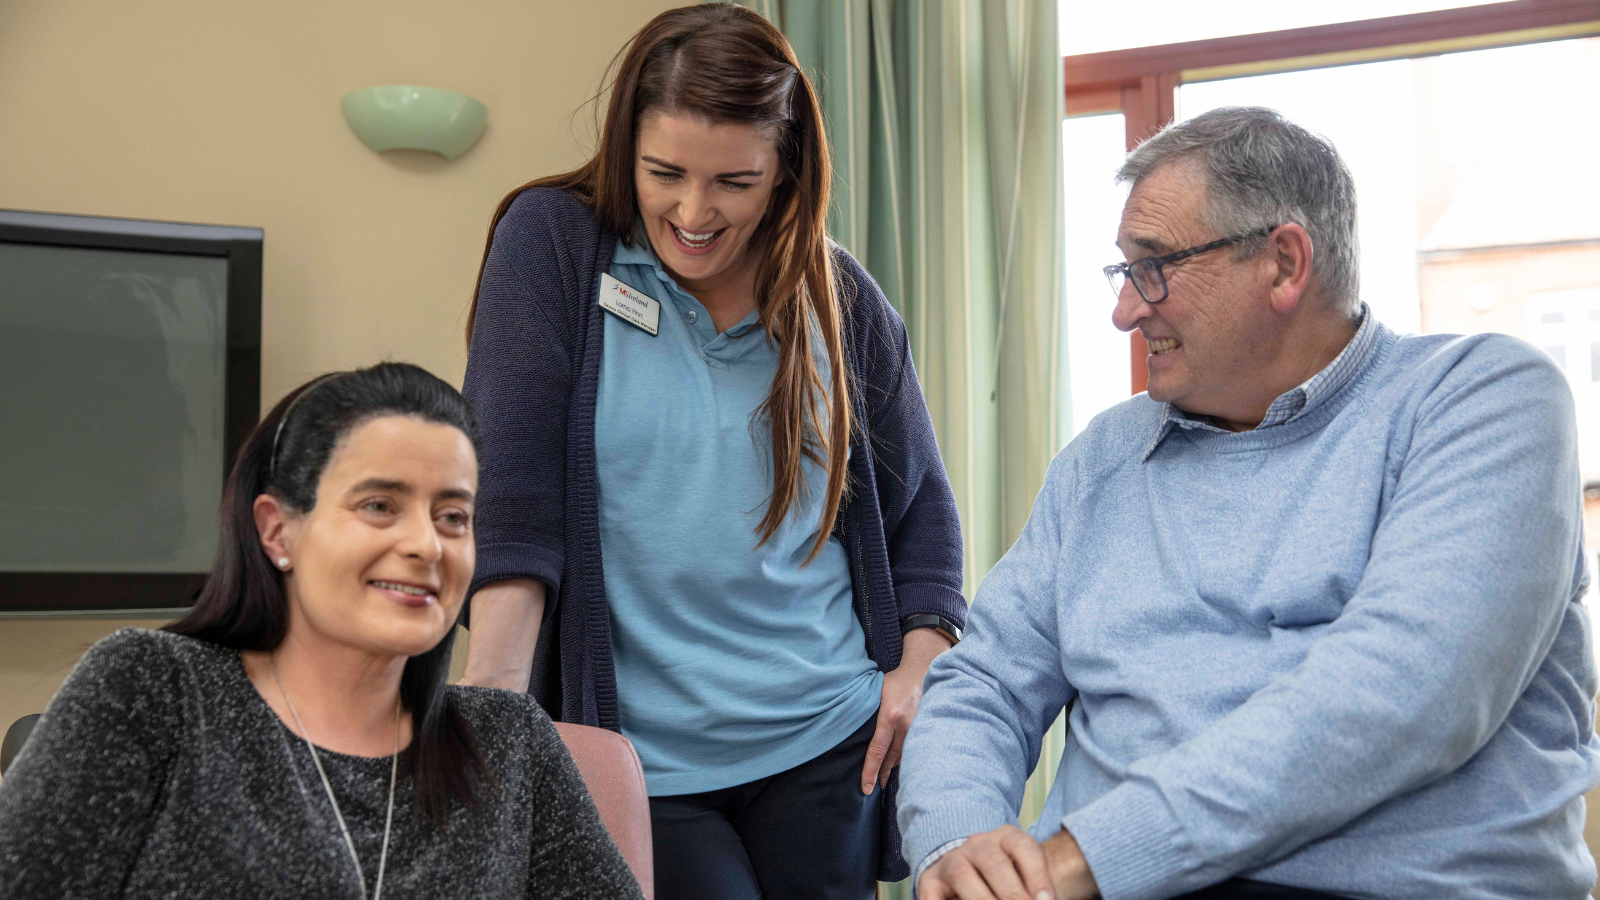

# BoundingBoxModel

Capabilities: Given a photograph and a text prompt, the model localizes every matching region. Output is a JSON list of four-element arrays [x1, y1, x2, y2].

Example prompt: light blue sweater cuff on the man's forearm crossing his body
[[1061, 781, 1194, 900]]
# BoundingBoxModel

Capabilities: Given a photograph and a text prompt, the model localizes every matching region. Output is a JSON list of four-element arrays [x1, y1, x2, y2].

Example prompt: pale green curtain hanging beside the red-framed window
[[736, 0, 1064, 897]]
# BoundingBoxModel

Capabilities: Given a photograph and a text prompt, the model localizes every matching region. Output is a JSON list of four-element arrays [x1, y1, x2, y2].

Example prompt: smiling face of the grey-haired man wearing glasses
[[1112, 162, 1277, 420]]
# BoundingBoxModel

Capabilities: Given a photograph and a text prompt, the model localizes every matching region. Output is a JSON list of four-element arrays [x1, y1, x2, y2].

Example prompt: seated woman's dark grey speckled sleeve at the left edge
[[0, 629, 181, 898]]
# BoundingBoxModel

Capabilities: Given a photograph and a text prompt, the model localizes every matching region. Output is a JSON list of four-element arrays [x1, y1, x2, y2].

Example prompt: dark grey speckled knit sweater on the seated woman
[[0, 629, 640, 900]]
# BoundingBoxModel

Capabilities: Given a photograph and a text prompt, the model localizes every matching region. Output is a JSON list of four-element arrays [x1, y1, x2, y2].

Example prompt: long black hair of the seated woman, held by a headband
[[165, 362, 488, 828]]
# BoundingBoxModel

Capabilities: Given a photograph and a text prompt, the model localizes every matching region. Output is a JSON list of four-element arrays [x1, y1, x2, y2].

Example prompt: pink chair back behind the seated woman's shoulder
[[555, 722, 656, 900]]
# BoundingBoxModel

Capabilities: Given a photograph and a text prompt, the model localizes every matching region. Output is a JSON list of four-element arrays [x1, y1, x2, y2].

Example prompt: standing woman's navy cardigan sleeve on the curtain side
[[835, 250, 966, 628]]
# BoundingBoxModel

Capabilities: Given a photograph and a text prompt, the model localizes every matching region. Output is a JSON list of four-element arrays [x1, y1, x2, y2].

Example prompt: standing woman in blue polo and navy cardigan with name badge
[[466, 3, 966, 900]]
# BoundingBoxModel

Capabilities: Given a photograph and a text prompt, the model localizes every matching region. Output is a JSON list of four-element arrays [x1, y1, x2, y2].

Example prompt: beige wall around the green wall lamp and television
[[0, 0, 678, 743]]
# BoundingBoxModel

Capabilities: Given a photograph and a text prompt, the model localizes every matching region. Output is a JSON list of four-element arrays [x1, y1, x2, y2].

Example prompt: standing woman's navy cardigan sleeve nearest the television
[[462, 189, 594, 597]]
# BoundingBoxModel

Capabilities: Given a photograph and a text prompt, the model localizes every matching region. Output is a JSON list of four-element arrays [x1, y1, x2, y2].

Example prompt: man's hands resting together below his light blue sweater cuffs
[[917, 825, 1099, 900]]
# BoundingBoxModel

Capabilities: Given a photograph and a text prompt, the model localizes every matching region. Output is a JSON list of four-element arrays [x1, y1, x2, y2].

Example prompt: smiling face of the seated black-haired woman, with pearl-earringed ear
[[256, 416, 478, 657]]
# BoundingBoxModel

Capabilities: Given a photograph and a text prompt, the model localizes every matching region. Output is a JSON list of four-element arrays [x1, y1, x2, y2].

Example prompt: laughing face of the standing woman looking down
[[634, 114, 778, 293]]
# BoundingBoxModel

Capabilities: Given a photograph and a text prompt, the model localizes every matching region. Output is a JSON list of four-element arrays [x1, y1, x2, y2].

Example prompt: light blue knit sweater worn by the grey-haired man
[[899, 323, 1600, 900]]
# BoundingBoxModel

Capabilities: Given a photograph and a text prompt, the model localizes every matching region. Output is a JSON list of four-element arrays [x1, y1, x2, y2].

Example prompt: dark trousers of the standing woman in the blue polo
[[650, 714, 885, 900]]
